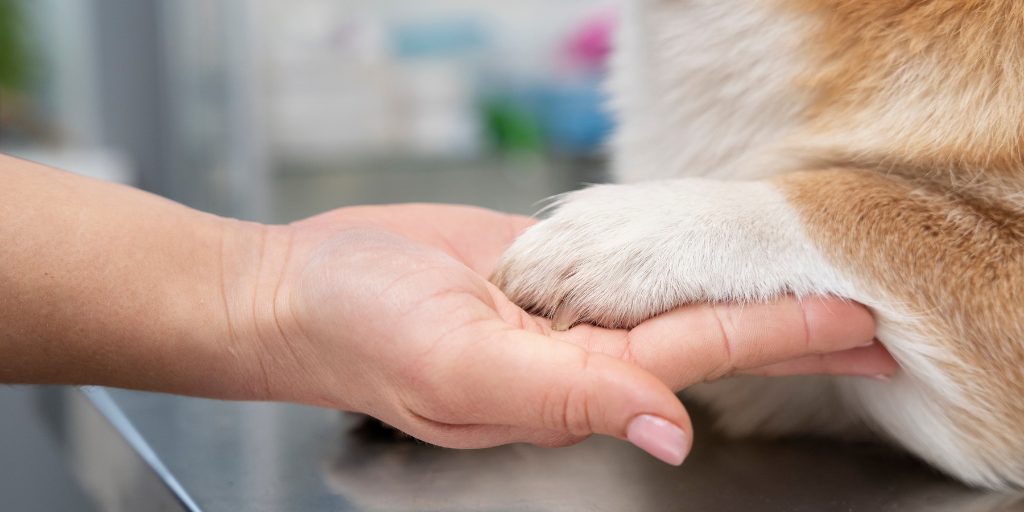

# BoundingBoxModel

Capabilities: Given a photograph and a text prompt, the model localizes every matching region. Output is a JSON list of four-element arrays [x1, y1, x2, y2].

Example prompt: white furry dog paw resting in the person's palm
[[492, 179, 830, 330]]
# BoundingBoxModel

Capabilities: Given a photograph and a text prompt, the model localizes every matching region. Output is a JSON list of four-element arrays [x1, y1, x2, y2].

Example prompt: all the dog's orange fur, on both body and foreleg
[[778, 0, 1024, 477]]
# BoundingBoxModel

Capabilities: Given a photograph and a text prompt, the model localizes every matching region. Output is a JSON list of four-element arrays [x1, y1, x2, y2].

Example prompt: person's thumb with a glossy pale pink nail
[[413, 319, 692, 464]]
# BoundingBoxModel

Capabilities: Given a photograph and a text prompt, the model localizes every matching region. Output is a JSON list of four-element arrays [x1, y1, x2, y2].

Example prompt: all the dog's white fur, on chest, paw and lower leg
[[499, 0, 1024, 487]]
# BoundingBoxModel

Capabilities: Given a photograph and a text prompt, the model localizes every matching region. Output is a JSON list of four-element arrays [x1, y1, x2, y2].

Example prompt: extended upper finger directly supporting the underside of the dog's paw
[[553, 297, 874, 390]]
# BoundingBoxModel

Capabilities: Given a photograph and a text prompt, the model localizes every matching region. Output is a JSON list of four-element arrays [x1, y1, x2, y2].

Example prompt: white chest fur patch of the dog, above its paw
[[609, 0, 808, 182]]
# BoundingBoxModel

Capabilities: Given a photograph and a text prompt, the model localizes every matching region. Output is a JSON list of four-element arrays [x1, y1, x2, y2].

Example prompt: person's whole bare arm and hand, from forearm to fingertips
[[0, 156, 896, 464]]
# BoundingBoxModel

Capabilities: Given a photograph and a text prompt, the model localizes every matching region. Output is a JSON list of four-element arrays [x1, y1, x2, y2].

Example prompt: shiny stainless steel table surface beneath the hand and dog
[[39, 388, 1024, 512]]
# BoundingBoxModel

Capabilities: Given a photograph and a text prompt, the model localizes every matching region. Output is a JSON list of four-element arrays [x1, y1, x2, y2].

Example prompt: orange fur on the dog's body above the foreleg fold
[[786, 0, 1024, 172]]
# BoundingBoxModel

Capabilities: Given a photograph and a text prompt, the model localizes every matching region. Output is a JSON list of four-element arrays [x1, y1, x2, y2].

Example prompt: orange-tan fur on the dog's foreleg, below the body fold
[[776, 170, 1024, 473]]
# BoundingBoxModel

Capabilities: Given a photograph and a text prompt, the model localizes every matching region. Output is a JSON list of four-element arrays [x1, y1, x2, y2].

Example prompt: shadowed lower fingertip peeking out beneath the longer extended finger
[[737, 343, 899, 380]]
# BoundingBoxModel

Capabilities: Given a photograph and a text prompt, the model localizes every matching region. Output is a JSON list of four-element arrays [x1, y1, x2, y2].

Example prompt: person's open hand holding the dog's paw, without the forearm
[[237, 205, 896, 464]]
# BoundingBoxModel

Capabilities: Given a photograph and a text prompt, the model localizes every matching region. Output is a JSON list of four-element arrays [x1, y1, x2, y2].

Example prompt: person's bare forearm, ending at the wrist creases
[[0, 156, 272, 398]]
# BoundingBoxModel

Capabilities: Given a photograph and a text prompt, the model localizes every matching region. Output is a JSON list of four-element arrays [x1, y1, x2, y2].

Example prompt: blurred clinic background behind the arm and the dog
[[0, 0, 617, 511]]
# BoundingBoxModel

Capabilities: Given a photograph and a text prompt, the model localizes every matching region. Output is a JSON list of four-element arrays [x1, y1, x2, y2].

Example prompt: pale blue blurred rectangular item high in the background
[[391, 17, 487, 58]]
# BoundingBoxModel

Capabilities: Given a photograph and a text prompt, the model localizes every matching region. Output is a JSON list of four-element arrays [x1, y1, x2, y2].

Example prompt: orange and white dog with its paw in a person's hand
[[494, 0, 1024, 487]]
